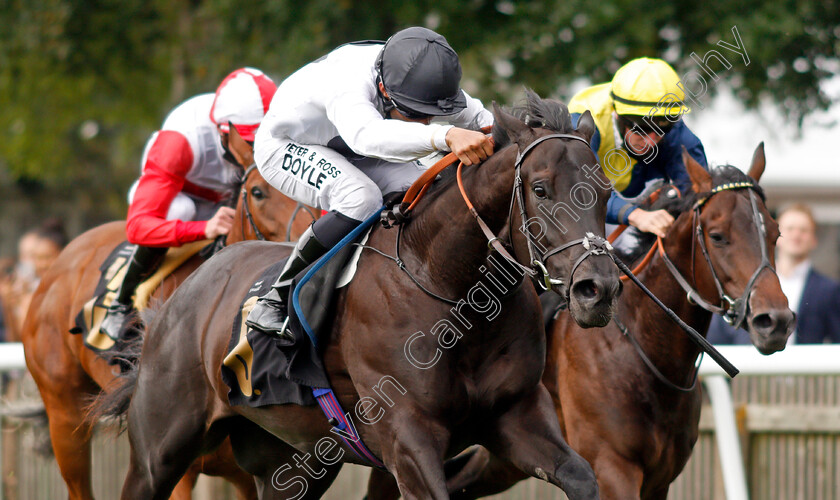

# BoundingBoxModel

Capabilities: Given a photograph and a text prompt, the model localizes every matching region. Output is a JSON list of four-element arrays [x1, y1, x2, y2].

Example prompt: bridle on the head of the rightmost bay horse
[[657, 181, 776, 328]]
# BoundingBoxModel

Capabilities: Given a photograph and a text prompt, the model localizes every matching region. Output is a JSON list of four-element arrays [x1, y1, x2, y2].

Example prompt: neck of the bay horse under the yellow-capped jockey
[[623, 215, 712, 376]]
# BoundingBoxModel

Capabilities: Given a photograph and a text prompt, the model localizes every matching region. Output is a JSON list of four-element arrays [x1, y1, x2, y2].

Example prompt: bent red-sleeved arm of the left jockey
[[126, 130, 207, 247]]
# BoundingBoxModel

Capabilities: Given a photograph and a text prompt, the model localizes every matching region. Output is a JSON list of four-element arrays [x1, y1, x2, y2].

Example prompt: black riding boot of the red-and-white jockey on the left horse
[[99, 245, 167, 340]]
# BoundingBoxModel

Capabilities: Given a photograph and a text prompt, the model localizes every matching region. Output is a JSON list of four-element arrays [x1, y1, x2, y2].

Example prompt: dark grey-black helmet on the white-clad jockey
[[376, 27, 467, 118]]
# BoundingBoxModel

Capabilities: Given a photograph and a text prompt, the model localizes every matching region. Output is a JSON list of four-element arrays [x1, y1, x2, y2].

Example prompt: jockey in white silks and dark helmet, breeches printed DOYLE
[[247, 27, 493, 340]]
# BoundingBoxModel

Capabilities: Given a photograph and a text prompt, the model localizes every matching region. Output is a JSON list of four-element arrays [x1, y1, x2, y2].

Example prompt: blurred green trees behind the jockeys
[[0, 0, 840, 255]]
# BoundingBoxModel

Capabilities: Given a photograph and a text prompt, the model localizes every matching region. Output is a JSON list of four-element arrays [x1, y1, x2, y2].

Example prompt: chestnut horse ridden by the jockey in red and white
[[22, 157, 311, 499]]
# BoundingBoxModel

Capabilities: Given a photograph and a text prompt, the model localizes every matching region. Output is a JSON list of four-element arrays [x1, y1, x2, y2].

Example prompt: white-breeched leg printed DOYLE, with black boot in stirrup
[[246, 138, 382, 341]]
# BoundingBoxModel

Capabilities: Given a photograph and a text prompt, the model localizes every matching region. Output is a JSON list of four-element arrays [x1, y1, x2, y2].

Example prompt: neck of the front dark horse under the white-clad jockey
[[402, 148, 516, 292]]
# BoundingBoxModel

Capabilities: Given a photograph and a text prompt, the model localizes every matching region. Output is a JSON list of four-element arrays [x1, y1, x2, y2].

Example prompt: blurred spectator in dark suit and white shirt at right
[[707, 203, 840, 345]]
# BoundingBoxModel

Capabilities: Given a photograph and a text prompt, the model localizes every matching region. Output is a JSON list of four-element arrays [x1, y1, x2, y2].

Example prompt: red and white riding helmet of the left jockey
[[210, 68, 277, 142]]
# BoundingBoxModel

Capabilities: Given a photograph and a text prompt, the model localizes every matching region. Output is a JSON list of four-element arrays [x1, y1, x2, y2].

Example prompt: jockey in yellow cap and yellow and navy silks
[[569, 57, 707, 236]]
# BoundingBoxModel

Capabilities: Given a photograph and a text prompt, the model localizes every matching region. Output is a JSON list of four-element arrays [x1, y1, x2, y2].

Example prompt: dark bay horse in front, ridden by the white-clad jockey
[[105, 95, 620, 499]]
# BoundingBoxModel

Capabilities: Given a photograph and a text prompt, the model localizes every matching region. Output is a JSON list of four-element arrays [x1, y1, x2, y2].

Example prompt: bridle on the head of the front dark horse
[[457, 134, 612, 301]]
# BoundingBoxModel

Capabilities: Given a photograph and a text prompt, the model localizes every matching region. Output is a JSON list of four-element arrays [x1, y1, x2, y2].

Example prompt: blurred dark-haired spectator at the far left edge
[[0, 219, 67, 341]]
